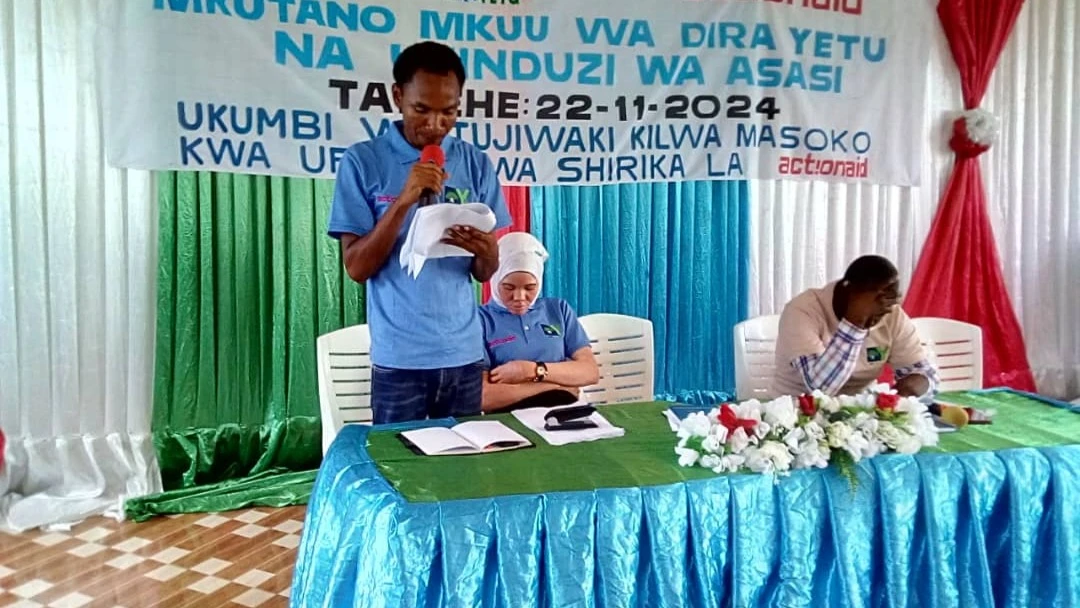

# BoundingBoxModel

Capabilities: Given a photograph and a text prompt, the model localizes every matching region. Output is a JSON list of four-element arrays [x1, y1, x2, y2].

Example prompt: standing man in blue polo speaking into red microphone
[[328, 42, 510, 423]]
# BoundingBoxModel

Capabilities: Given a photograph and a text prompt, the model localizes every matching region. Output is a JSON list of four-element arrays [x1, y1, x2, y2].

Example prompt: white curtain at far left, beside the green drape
[[0, 0, 161, 529]]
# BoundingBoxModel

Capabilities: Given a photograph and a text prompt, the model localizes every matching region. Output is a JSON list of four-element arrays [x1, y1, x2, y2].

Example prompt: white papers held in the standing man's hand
[[397, 203, 495, 279]]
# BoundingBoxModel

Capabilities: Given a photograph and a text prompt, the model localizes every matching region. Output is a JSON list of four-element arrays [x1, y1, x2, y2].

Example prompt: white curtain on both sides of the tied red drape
[[750, 0, 1080, 398]]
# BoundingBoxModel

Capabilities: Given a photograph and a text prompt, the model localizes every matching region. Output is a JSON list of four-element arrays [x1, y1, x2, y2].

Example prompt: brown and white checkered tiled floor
[[0, 506, 305, 608]]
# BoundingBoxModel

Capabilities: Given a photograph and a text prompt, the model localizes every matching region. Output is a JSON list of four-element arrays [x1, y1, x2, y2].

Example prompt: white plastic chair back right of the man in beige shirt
[[912, 316, 983, 391]]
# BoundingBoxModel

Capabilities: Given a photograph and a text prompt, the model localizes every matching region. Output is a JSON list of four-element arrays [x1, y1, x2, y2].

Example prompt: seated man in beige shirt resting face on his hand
[[773, 256, 937, 397]]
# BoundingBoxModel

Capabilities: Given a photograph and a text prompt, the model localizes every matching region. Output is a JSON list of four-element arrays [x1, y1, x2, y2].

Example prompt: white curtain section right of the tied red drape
[[983, 0, 1080, 398]]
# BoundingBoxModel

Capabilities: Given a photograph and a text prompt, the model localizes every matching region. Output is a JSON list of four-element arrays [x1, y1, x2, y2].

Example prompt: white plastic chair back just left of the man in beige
[[734, 314, 780, 401]]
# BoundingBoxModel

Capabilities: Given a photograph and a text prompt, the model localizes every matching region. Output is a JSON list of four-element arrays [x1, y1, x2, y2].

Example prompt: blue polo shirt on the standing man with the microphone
[[328, 121, 510, 369]]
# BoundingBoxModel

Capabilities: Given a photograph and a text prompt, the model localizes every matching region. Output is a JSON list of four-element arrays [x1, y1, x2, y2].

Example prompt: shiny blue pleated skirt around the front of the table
[[292, 427, 1080, 608]]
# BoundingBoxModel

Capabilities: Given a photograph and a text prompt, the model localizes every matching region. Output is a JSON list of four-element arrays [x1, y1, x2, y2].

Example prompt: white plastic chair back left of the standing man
[[315, 325, 372, 454]]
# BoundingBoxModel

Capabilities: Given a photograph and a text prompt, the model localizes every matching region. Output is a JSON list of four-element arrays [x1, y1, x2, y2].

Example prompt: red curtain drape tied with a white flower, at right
[[904, 0, 1035, 391]]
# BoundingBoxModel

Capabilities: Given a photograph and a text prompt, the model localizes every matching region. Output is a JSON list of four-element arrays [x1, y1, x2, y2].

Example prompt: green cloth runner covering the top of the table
[[367, 392, 1080, 502]]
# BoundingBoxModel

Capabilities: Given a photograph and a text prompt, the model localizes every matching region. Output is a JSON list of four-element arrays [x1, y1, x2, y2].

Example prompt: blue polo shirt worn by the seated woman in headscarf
[[480, 298, 589, 369]]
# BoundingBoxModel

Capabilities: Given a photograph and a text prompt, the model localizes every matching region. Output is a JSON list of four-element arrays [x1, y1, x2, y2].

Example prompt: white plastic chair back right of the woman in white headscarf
[[580, 314, 656, 405]]
